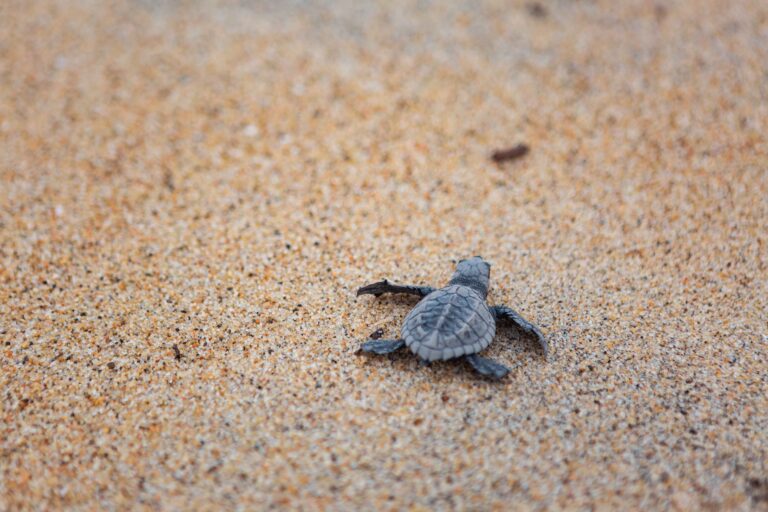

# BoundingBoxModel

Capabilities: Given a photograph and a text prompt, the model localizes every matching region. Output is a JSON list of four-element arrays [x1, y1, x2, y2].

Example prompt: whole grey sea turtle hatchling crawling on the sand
[[357, 256, 547, 379]]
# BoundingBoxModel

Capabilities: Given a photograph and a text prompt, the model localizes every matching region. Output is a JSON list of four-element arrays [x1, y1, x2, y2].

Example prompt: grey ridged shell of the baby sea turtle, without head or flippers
[[401, 285, 496, 361]]
